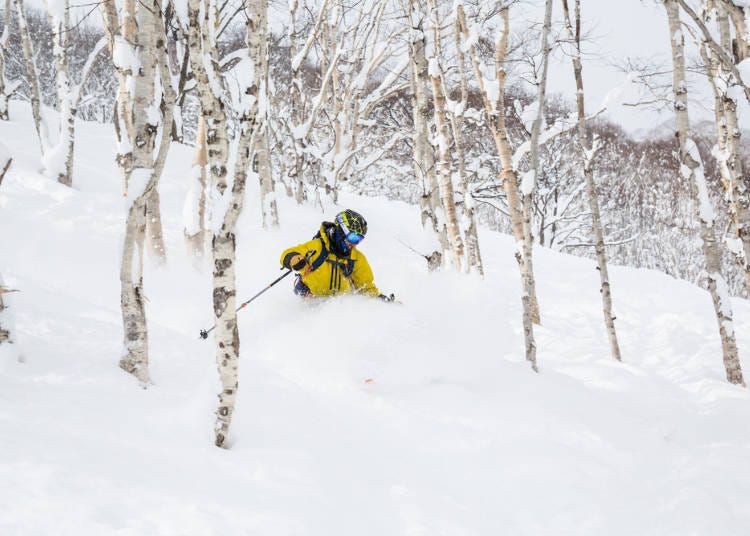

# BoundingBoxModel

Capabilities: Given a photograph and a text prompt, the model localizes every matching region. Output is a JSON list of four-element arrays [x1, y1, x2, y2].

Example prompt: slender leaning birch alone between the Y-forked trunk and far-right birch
[[562, 0, 622, 361]]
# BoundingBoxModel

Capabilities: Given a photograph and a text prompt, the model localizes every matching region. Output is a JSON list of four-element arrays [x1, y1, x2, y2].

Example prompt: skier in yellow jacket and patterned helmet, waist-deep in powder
[[281, 209, 394, 301]]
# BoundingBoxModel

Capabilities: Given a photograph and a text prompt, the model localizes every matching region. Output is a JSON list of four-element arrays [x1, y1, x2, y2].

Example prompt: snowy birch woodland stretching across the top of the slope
[[0, 0, 750, 445]]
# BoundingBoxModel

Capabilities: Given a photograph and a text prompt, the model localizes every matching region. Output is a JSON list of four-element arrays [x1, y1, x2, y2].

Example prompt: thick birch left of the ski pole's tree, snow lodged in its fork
[[100, 0, 174, 387]]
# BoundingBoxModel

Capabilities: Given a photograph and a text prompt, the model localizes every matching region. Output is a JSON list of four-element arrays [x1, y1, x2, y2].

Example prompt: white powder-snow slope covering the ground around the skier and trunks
[[0, 102, 750, 536]]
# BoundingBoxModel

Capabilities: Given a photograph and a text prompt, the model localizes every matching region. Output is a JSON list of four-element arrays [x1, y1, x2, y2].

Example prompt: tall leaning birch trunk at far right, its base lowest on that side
[[664, 0, 745, 386]]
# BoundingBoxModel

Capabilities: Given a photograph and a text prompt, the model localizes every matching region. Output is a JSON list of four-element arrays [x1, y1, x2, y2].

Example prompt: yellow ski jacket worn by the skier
[[281, 224, 380, 297]]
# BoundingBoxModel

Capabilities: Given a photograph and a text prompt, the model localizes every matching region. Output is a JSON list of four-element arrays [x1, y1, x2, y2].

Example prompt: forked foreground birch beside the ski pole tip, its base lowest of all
[[188, 0, 267, 447]]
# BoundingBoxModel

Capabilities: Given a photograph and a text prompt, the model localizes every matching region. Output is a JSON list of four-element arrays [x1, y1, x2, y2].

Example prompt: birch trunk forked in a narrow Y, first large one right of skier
[[456, 1, 537, 371]]
